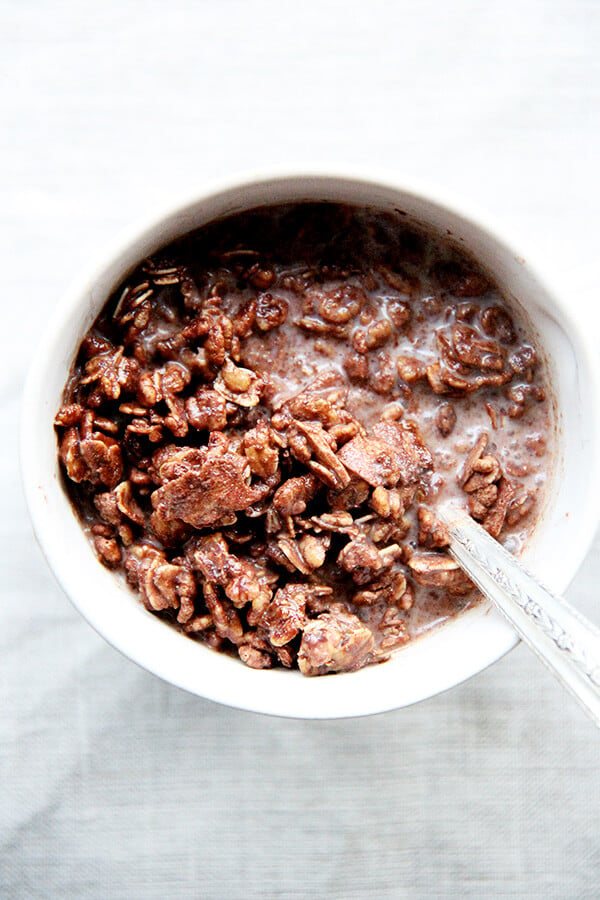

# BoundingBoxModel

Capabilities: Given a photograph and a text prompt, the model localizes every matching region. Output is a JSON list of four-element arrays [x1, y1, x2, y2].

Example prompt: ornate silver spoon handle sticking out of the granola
[[440, 504, 600, 727]]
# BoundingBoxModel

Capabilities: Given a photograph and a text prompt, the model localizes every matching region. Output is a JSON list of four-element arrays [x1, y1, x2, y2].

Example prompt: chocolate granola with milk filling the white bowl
[[56, 205, 548, 675]]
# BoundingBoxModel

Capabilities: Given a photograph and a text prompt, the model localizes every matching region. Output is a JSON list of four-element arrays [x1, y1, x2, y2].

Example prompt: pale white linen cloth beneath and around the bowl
[[0, 0, 600, 900]]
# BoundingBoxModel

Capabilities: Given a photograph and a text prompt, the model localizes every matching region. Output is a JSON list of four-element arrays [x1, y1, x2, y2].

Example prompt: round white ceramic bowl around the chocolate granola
[[22, 174, 600, 718]]
